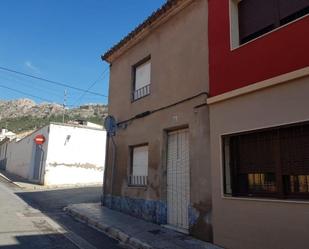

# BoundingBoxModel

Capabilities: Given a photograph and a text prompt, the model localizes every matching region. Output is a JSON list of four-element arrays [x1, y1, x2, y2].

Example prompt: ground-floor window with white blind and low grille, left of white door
[[128, 145, 148, 186]]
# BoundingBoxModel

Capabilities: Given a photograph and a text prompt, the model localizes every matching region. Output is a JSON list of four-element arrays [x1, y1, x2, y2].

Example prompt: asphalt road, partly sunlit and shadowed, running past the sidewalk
[[0, 179, 124, 249]]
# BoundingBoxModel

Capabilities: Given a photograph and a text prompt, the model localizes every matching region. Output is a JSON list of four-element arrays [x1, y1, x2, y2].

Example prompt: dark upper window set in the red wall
[[238, 0, 309, 44]]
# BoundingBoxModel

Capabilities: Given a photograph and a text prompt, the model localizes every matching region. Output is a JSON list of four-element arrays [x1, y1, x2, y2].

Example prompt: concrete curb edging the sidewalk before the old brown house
[[63, 207, 155, 249]]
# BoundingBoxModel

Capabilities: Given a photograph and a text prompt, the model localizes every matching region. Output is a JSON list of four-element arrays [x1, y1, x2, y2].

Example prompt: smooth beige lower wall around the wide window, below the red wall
[[209, 74, 309, 249]]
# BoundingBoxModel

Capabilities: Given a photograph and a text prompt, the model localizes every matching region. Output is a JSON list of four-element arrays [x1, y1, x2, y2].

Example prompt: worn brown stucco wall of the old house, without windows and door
[[105, 0, 212, 241]]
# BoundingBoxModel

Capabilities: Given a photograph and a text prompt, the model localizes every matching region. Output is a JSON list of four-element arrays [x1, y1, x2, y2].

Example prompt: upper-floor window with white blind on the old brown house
[[132, 57, 151, 100]]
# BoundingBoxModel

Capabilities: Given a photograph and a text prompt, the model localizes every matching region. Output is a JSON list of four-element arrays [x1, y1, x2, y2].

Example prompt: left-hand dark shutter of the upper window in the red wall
[[238, 0, 276, 43]]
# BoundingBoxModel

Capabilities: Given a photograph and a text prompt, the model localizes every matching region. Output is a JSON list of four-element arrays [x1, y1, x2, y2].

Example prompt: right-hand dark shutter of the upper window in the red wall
[[279, 0, 309, 20]]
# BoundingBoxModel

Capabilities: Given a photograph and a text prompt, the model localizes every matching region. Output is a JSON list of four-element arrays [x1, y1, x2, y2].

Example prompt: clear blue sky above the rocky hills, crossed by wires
[[0, 0, 165, 105]]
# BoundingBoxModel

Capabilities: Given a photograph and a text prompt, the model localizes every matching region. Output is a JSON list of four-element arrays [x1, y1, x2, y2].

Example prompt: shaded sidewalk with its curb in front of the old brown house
[[65, 203, 222, 249]]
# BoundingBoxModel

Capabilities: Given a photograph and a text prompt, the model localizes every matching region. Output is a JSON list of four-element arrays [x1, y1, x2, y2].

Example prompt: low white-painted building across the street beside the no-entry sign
[[5, 123, 106, 185]]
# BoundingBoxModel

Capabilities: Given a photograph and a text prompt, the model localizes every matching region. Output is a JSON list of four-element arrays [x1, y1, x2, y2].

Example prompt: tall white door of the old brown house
[[167, 130, 190, 230]]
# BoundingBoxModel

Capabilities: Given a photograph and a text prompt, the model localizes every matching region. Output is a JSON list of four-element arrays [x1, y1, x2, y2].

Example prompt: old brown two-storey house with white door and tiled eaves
[[102, 0, 212, 241]]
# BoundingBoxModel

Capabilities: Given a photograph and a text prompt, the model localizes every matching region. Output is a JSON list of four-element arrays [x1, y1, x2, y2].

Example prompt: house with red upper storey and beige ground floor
[[207, 0, 309, 249]]
